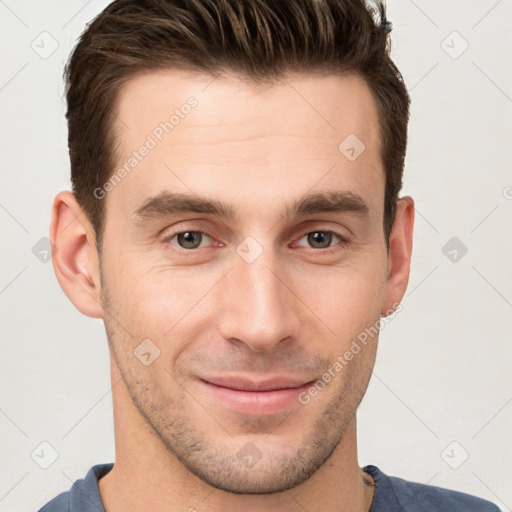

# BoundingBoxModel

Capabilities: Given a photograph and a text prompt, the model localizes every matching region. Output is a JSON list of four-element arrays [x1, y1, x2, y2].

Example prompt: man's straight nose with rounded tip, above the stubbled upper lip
[[217, 244, 300, 352]]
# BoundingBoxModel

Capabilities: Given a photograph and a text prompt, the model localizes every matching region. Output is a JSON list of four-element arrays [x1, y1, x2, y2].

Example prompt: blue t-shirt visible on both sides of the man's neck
[[39, 463, 500, 512]]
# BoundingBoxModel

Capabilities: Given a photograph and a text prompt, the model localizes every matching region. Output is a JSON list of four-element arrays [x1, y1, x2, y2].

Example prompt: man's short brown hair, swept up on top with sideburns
[[64, 0, 410, 249]]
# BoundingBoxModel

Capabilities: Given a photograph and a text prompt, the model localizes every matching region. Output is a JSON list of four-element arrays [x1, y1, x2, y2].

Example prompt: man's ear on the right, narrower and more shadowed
[[381, 196, 414, 316]]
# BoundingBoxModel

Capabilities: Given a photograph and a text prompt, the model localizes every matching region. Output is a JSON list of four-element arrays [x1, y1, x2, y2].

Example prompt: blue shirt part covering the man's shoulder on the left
[[38, 463, 114, 512]]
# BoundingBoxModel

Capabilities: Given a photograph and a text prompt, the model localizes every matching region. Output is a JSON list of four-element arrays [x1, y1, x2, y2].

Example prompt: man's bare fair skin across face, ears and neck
[[51, 70, 414, 512]]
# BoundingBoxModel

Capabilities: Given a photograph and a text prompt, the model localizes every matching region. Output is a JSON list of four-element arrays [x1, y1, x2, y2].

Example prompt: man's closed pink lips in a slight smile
[[199, 376, 313, 416]]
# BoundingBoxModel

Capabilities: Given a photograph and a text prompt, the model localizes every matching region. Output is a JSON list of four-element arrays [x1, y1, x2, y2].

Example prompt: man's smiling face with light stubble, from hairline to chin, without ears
[[101, 71, 388, 493]]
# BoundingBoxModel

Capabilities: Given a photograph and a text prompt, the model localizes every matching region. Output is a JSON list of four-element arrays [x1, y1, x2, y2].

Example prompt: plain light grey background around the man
[[0, 0, 512, 512]]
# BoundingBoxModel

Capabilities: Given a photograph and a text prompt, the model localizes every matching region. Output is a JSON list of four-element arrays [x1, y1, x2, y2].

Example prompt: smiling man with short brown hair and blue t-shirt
[[41, 0, 497, 512]]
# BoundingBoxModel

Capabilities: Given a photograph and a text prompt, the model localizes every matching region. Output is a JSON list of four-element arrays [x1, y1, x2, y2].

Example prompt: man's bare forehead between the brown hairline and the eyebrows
[[109, 70, 384, 222]]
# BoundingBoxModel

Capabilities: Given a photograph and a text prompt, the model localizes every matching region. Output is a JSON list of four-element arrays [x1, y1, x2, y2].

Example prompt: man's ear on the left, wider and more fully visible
[[50, 191, 103, 318]]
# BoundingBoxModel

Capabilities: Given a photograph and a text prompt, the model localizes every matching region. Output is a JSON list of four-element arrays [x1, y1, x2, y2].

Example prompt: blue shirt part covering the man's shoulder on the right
[[364, 466, 500, 512]]
